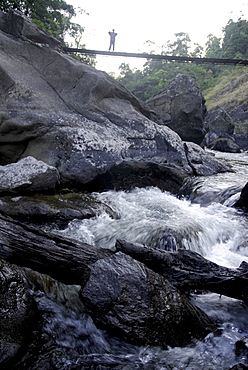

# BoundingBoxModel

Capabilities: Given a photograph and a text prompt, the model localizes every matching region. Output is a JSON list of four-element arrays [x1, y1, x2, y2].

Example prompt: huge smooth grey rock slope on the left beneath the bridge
[[0, 13, 230, 194]]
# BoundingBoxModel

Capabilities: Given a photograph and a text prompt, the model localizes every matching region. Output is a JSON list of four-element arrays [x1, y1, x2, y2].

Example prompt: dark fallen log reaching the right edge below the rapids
[[116, 240, 248, 303]]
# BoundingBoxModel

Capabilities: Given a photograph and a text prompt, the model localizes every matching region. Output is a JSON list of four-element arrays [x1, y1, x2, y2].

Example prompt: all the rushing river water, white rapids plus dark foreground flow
[[33, 153, 248, 370]]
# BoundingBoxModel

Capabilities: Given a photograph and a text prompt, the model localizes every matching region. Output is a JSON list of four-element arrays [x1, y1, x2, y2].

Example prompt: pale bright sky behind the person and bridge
[[66, 0, 248, 76]]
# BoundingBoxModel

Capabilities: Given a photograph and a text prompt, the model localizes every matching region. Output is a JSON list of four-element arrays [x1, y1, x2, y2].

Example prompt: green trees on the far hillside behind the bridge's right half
[[118, 19, 248, 101]]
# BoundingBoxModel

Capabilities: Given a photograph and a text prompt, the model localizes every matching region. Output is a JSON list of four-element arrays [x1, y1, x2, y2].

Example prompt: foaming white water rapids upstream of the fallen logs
[[57, 150, 248, 267]]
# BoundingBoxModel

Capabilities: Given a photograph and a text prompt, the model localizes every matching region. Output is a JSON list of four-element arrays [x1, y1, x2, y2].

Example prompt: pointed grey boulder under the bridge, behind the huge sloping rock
[[147, 74, 206, 144]]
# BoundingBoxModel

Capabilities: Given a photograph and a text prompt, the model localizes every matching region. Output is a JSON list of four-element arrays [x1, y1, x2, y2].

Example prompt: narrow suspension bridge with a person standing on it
[[63, 47, 248, 66]]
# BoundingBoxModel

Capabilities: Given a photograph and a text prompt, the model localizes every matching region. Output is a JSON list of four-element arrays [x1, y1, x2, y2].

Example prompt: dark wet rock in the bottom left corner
[[0, 260, 38, 368]]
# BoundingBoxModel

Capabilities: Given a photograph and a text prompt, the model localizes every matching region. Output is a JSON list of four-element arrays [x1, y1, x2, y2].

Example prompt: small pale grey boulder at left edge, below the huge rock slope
[[0, 157, 59, 193]]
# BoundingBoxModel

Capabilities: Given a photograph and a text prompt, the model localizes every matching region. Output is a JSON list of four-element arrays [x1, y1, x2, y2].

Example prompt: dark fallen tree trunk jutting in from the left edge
[[0, 216, 113, 284]]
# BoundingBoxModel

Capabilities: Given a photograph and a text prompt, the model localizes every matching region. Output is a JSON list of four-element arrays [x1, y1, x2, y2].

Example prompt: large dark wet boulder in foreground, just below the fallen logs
[[81, 252, 213, 348]]
